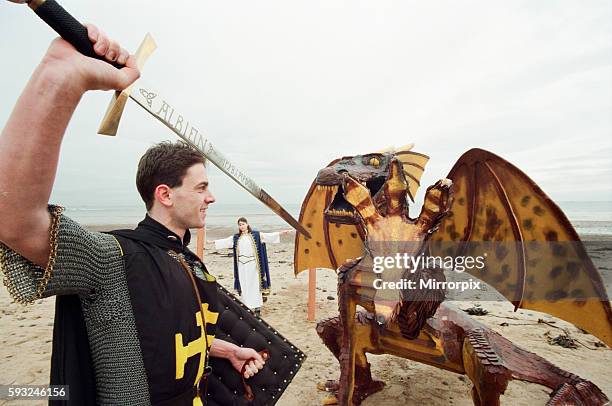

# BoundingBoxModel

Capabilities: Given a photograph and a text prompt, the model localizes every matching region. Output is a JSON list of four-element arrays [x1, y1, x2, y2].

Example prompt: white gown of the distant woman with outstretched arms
[[215, 232, 280, 309]]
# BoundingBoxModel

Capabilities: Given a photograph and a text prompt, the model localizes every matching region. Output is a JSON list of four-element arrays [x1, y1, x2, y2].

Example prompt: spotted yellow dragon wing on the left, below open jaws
[[294, 160, 365, 275]]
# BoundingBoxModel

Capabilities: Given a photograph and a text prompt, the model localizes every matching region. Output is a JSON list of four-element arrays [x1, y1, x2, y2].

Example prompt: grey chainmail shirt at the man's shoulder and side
[[0, 209, 150, 405]]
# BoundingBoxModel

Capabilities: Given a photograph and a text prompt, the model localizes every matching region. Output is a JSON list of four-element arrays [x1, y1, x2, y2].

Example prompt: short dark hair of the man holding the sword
[[136, 141, 206, 210]]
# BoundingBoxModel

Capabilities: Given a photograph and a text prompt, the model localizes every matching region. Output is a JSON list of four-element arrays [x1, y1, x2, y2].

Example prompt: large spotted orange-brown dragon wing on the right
[[430, 149, 612, 346]]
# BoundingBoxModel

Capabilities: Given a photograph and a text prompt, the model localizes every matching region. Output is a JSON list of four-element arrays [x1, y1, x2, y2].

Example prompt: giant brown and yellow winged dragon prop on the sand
[[295, 147, 612, 406]]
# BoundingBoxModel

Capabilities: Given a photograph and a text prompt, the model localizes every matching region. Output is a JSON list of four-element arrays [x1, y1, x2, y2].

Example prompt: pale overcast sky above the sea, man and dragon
[[0, 0, 612, 214]]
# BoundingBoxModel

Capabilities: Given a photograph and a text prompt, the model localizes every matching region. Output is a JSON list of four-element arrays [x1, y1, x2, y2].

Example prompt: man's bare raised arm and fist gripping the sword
[[0, 25, 139, 267]]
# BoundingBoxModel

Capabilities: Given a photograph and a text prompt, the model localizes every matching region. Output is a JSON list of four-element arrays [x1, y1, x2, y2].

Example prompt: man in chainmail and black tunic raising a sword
[[0, 25, 303, 405]]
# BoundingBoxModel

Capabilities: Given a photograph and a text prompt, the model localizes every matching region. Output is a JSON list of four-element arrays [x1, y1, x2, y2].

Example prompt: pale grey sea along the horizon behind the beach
[[66, 201, 612, 239]]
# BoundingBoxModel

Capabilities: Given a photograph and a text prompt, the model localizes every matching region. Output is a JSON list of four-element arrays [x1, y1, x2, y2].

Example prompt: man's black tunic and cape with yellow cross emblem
[[51, 216, 220, 405]]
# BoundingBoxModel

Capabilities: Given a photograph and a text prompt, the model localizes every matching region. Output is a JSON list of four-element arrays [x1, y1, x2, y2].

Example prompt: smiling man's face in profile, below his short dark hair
[[172, 164, 215, 229]]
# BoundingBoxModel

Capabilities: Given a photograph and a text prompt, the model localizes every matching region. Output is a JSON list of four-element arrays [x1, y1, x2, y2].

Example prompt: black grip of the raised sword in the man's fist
[[27, 0, 124, 69]]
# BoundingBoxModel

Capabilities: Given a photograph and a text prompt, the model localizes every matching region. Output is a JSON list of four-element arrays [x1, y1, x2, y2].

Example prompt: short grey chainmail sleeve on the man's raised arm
[[0, 206, 121, 304]]
